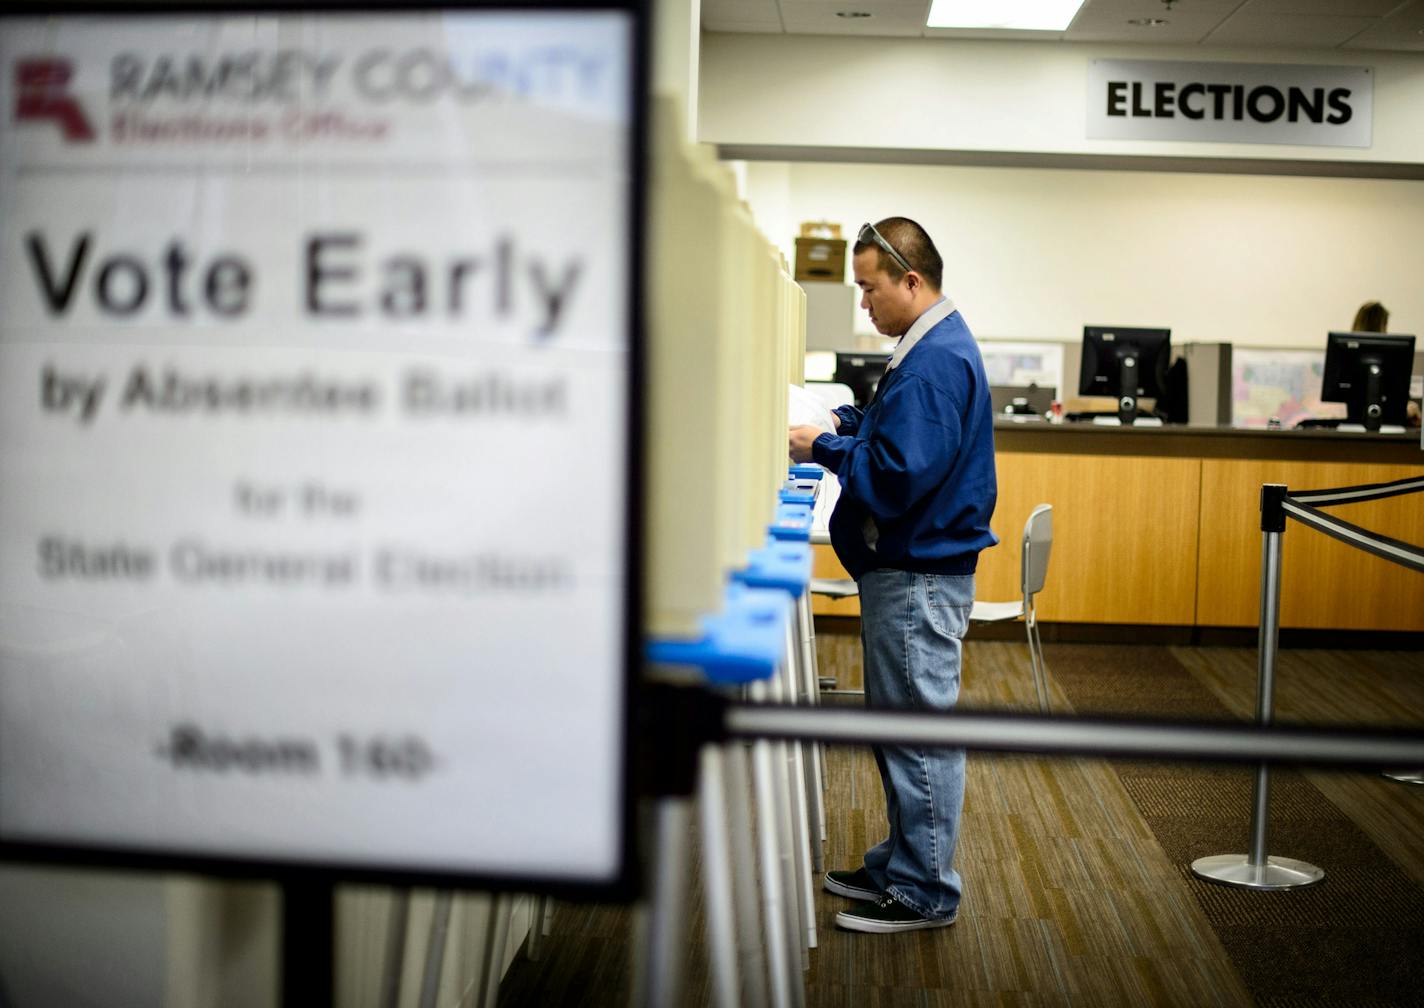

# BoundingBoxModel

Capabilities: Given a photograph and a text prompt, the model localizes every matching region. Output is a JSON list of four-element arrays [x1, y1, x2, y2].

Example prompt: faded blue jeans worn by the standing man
[[860, 569, 974, 918]]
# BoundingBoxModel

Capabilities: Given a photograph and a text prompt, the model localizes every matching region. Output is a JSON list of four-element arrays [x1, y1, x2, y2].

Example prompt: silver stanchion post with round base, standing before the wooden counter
[[1192, 483, 1326, 890]]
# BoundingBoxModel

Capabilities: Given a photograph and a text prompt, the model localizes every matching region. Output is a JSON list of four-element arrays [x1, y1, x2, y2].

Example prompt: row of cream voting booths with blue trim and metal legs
[[635, 88, 824, 1005]]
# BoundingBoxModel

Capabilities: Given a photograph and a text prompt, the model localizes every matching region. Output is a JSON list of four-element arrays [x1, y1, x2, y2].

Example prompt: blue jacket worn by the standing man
[[812, 312, 998, 581]]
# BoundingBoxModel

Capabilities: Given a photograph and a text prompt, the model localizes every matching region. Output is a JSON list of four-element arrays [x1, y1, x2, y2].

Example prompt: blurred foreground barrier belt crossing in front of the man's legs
[[726, 703, 1424, 769]]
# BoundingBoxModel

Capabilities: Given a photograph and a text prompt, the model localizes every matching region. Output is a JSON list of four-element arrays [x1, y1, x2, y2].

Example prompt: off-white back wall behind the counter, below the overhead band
[[746, 162, 1424, 347]]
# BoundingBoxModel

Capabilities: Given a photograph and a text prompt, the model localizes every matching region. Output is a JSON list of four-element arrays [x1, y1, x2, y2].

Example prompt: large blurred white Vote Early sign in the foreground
[[0, 10, 635, 884]]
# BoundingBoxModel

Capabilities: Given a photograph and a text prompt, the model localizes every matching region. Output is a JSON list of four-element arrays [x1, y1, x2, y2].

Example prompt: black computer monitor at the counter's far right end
[[1320, 333, 1414, 430]]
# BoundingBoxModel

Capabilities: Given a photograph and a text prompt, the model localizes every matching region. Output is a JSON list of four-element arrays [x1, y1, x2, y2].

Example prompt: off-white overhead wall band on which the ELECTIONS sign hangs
[[699, 33, 1424, 162]]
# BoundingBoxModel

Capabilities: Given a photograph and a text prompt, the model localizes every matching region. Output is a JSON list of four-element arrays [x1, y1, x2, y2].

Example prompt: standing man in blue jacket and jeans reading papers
[[790, 216, 998, 934]]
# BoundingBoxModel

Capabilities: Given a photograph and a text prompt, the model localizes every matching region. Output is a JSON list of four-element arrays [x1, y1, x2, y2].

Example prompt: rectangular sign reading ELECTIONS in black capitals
[[1088, 60, 1374, 147]]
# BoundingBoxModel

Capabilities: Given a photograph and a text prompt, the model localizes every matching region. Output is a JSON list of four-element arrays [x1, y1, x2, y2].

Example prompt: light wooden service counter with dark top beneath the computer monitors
[[815, 420, 1424, 631]]
